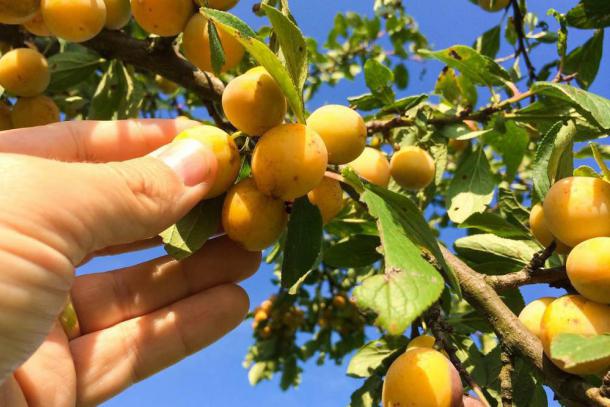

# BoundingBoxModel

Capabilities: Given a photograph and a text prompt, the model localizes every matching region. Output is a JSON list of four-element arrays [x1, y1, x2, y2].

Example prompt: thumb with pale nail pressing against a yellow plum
[[57, 139, 217, 263]]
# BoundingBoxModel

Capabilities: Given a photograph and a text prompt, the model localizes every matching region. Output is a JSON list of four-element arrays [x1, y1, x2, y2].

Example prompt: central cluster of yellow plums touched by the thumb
[[177, 67, 435, 251]]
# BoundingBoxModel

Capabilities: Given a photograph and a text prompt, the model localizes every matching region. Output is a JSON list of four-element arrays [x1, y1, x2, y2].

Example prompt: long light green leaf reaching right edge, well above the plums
[[532, 82, 610, 130]]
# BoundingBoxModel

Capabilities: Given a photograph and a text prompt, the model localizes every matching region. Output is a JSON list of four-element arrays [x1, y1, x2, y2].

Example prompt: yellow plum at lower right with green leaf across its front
[[541, 295, 610, 375]]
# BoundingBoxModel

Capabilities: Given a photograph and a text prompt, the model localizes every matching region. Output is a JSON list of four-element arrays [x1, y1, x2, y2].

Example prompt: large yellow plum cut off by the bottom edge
[[381, 348, 464, 407]]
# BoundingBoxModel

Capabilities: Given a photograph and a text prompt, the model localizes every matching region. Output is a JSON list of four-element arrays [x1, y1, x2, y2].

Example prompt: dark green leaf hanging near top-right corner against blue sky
[[564, 30, 604, 89]]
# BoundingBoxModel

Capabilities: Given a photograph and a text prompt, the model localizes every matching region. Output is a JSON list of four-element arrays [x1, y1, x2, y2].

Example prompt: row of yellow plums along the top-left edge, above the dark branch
[[0, 0, 244, 72]]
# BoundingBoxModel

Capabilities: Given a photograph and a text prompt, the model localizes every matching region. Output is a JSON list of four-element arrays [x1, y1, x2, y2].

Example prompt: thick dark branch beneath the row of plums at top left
[[0, 24, 224, 103]]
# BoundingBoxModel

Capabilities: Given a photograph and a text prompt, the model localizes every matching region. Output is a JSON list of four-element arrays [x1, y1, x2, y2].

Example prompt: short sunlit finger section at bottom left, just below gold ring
[[13, 324, 76, 407]]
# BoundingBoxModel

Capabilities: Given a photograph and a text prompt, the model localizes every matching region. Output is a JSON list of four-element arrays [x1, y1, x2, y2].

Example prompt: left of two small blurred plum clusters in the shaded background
[[252, 296, 305, 339]]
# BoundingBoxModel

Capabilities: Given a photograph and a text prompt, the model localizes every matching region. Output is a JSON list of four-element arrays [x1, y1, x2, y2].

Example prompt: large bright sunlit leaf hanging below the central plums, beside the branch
[[354, 185, 444, 335]]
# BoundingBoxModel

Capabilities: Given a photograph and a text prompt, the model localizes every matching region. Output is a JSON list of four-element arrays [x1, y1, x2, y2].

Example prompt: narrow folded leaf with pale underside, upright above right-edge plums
[[532, 122, 576, 202]]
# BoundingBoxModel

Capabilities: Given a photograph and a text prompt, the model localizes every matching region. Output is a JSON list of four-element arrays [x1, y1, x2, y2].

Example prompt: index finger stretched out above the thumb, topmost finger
[[0, 119, 200, 162]]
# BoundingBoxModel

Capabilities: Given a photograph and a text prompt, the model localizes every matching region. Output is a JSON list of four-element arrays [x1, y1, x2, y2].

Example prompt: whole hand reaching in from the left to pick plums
[[0, 120, 260, 407]]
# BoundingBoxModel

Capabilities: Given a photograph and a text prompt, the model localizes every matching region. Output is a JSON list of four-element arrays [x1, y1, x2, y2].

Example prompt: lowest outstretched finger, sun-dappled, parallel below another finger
[[70, 285, 249, 406]]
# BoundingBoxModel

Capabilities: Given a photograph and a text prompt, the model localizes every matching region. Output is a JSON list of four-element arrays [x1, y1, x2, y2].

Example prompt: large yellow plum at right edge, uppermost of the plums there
[[544, 177, 610, 247]]
